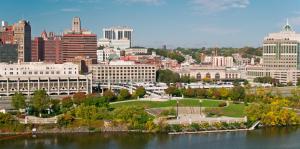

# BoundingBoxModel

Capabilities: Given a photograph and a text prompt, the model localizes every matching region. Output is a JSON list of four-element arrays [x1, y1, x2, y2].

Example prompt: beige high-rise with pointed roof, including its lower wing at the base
[[246, 22, 300, 84]]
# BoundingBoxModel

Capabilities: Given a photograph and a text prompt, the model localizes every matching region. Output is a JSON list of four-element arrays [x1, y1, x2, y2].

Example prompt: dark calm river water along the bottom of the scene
[[0, 127, 300, 149]]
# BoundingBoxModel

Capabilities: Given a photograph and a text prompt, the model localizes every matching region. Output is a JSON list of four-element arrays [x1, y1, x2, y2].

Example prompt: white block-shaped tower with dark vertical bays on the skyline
[[98, 27, 133, 50]]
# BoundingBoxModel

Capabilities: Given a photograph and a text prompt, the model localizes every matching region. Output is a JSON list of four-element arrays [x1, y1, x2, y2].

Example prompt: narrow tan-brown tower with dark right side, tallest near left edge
[[13, 20, 31, 62]]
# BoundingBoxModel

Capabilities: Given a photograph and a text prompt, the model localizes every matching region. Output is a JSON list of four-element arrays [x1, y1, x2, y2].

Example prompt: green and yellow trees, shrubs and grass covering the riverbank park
[[0, 86, 300, 135]]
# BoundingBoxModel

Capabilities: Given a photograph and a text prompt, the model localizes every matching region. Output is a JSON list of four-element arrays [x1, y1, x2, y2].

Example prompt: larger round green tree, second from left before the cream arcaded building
[[31, 90, 50, 116]]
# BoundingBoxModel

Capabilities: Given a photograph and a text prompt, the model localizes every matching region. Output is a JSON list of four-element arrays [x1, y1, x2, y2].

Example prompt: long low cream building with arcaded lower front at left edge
[[0, 62, 92, 96]]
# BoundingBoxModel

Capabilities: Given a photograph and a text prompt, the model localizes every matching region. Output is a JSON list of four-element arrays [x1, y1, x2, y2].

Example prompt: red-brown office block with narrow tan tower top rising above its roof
[[62, 18, 97, 62]]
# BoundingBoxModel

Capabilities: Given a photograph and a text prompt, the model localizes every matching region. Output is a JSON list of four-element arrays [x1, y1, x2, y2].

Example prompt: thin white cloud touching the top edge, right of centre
[[190, 0, 250, 13]]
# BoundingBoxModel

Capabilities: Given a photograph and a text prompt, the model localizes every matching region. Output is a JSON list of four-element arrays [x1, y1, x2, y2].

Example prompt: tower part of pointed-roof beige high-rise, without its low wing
[[263, 21, 300, 70]]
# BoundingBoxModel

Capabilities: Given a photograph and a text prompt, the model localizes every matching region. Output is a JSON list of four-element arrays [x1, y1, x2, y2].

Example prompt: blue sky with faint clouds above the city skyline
[[0, 0, 300, 47]]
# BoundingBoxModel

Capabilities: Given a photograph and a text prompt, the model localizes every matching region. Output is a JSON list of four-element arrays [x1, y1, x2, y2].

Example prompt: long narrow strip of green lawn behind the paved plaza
[[111, 99, 222, 108]]
